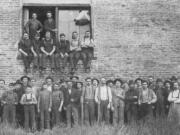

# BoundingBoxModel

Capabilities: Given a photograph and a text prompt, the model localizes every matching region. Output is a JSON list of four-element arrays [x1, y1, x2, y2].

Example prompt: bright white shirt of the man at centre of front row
[[95, 85, 112, 102]]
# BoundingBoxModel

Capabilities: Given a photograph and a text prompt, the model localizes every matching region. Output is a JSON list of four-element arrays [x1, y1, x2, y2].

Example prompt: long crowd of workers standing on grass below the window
[[0, 76, 180, 131]]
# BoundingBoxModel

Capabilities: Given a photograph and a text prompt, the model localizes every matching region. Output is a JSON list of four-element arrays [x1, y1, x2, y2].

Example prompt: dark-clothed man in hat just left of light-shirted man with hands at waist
[[125, 80, 139, 123]]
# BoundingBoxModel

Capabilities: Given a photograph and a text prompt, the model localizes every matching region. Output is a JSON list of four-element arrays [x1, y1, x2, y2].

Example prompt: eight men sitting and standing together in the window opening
[[18, 12, 95, 73]]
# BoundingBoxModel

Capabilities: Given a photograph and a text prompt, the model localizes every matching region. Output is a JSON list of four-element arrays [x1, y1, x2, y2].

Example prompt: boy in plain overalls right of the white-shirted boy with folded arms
[[38, 84, 52, 130]]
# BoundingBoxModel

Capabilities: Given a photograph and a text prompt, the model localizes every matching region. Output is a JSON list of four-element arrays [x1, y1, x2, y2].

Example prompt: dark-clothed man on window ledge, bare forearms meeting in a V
[[40, 31, 56, 73]]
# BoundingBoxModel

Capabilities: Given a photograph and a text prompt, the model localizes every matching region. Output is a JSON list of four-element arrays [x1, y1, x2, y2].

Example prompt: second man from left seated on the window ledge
[[31, 33, 42, 70]]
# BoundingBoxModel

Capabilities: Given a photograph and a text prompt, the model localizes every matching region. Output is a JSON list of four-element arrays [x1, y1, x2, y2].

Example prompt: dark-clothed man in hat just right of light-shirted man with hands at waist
[[154, 78, 165, 117]]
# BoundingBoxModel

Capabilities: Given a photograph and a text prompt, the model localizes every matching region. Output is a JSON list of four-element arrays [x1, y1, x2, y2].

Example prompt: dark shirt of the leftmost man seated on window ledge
[[18, 39, 31, 54]]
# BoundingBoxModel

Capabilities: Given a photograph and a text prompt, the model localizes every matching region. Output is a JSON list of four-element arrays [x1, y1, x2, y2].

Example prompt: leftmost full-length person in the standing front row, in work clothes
[[1, 83, 18, 127]]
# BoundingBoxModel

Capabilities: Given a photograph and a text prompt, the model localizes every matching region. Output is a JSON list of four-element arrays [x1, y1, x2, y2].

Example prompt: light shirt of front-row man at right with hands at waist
[[139, 89, 157, 103]]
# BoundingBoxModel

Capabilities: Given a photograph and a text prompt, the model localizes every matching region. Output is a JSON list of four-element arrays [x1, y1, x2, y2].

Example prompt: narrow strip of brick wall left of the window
[[0, 0, 23, 82]]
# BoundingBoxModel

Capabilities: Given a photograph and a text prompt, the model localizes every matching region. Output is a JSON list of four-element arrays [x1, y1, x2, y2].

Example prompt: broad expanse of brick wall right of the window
[[93, 0, 180, 78]]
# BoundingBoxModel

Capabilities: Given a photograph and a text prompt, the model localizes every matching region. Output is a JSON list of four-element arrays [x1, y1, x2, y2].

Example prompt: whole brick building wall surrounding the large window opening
[[0, 0, 180, 81]]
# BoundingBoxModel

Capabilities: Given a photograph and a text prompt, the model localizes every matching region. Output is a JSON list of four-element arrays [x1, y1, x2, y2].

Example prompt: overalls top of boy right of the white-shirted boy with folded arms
[[38, 90, 52, 111]]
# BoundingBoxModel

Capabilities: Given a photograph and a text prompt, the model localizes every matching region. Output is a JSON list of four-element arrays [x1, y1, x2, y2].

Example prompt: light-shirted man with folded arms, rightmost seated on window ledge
[[81, 31, 95, 72]]
